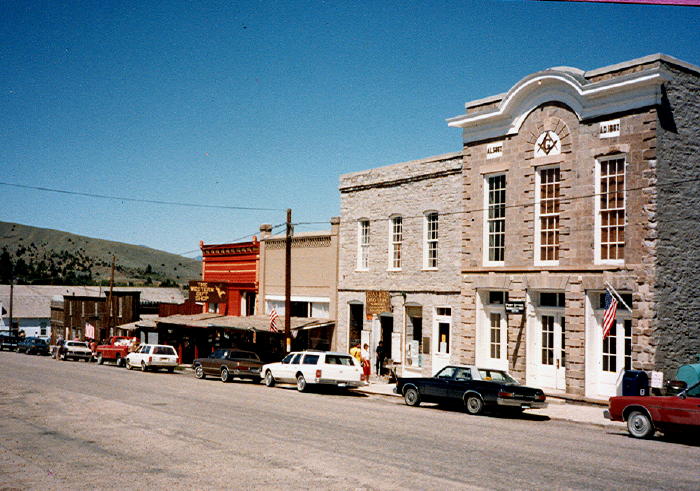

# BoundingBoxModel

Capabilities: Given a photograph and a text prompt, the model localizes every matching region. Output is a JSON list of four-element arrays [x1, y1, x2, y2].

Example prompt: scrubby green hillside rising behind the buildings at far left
[[0, 222, 202, 286]]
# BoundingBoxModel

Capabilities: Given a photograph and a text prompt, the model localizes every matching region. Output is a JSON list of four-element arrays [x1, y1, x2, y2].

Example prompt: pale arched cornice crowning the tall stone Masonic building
[[448, 67, 670, 143]]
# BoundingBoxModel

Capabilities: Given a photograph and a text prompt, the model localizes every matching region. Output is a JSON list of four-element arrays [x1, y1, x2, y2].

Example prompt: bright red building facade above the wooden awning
[[196, 237, 260, 316]]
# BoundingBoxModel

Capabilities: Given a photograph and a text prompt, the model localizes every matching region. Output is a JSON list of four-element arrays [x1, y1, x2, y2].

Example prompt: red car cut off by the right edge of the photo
[[603, 382, 700, 438]]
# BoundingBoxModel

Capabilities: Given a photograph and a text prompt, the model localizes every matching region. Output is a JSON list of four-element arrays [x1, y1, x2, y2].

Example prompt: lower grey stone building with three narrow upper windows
[[337, 153, 462, 375]]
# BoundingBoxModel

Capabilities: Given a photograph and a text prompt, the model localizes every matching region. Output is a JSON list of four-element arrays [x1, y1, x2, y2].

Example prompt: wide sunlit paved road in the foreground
[[0, 352, 700, 489]]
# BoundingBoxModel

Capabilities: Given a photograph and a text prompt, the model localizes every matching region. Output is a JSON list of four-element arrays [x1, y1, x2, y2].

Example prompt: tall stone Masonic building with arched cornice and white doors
[[448, 55, 700, 399]]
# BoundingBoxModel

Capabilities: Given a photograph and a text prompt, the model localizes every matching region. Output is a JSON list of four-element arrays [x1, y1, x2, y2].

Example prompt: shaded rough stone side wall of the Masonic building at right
[[652, 66, 700, 377]]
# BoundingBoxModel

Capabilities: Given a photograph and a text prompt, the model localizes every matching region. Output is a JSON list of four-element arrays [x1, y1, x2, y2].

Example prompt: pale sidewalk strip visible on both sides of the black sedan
[[355, 382, 624, 428]]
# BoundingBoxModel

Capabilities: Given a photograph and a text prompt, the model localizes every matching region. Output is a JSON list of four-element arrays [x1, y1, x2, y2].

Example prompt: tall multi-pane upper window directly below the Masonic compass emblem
[[537, 167, 561, 263]]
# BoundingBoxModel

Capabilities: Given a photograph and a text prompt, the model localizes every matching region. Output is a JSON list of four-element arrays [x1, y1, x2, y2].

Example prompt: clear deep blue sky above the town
[[0, 0, 700, 257]]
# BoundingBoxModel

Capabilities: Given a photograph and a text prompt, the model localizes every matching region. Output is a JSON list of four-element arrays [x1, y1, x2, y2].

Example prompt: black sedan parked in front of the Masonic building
[[394, 365, 547, 415]]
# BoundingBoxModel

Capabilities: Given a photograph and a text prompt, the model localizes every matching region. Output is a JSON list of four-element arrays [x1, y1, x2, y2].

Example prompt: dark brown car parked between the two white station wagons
[[192, 349, 263, 383]]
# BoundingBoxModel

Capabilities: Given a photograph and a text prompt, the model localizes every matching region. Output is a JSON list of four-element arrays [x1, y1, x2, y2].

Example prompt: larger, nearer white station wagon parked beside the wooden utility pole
[[262, 351, 364, 392]]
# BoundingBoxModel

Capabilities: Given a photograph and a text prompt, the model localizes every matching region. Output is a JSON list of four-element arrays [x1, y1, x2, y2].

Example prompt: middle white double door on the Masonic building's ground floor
[[527, 316, 566, 391]]
